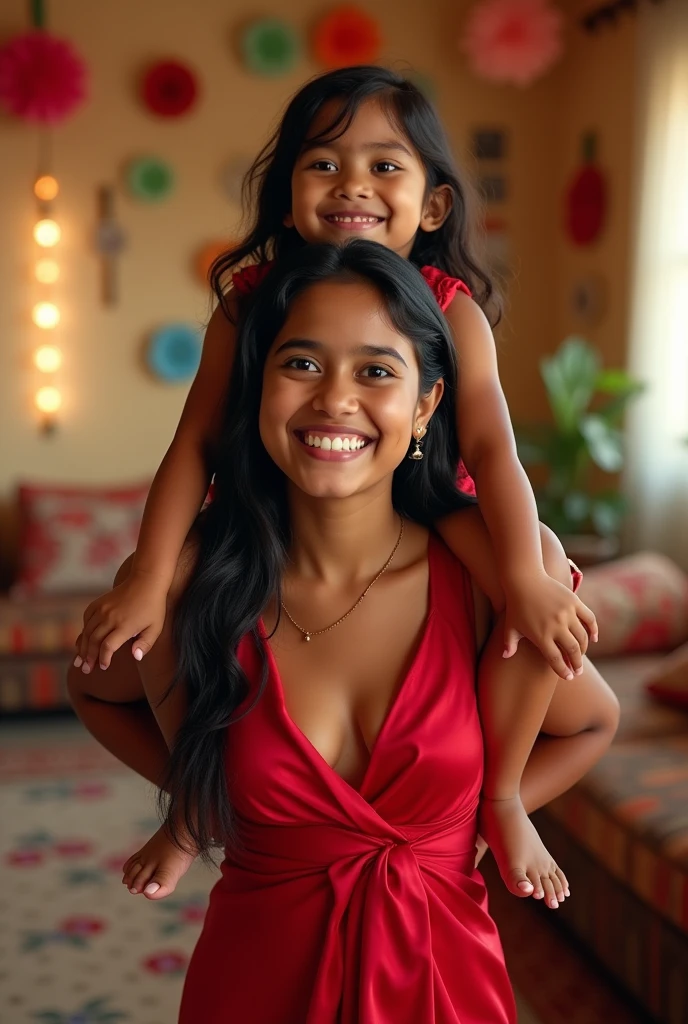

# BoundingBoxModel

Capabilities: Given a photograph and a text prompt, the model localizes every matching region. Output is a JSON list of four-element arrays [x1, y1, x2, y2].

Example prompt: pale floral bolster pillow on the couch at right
[[578, 551, 688, 658]]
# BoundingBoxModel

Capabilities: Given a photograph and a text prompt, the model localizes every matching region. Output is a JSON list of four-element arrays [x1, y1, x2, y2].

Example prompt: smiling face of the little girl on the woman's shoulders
[[287, 99, 450, 257]]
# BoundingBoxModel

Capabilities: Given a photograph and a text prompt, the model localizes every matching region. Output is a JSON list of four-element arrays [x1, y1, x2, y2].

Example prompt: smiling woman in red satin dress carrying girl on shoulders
[[71, 241, 615, 1024]]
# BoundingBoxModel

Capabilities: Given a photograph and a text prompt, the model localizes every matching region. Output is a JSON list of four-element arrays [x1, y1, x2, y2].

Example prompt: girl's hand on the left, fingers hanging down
[[74, 575, 167, 674]]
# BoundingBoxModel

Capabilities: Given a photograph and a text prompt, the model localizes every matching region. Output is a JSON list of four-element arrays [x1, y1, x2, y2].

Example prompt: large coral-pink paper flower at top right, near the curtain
[[462, 0, 563, 86]]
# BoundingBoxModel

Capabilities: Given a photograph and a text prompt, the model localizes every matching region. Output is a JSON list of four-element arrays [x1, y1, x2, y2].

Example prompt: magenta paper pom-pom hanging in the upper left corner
[[0, 32, 87, 125]]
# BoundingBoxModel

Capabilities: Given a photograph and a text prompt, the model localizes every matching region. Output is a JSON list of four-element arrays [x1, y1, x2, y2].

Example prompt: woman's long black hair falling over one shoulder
[[161, 240, 474, 852]]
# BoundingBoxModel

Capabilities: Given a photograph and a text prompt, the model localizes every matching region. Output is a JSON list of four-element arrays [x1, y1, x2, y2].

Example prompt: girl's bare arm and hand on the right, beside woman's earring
[[440, 293, 596, 672]]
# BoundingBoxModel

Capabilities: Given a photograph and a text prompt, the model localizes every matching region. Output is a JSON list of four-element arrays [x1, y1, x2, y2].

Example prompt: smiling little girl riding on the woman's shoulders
[[72, 67, 597, 896]]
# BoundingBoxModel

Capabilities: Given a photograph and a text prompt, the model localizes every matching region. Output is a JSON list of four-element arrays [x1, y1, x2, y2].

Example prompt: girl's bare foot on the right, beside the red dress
[[479, 797, 570, 910]]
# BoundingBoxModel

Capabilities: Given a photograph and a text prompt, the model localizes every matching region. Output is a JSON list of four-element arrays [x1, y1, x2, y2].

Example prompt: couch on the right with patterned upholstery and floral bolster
[[535, 555, 688, 1024]]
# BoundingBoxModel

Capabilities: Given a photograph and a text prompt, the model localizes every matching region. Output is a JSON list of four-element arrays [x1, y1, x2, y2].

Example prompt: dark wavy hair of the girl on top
[[210, 66, 500, 325]]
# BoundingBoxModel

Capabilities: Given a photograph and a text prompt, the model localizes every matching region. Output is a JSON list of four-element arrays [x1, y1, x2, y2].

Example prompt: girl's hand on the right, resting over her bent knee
[[504, 571, 597, 679]]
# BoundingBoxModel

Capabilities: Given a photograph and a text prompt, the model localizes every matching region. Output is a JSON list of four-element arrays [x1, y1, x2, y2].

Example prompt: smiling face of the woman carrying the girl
[[260, 281, 443, 499]]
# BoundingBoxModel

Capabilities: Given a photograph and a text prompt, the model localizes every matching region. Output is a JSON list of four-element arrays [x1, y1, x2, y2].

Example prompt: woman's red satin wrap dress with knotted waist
[[179, 538, 516, 1024]]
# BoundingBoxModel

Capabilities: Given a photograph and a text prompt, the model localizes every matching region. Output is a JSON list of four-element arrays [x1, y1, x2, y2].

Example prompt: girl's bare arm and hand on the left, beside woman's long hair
[[78, 301, 237, 673]]
